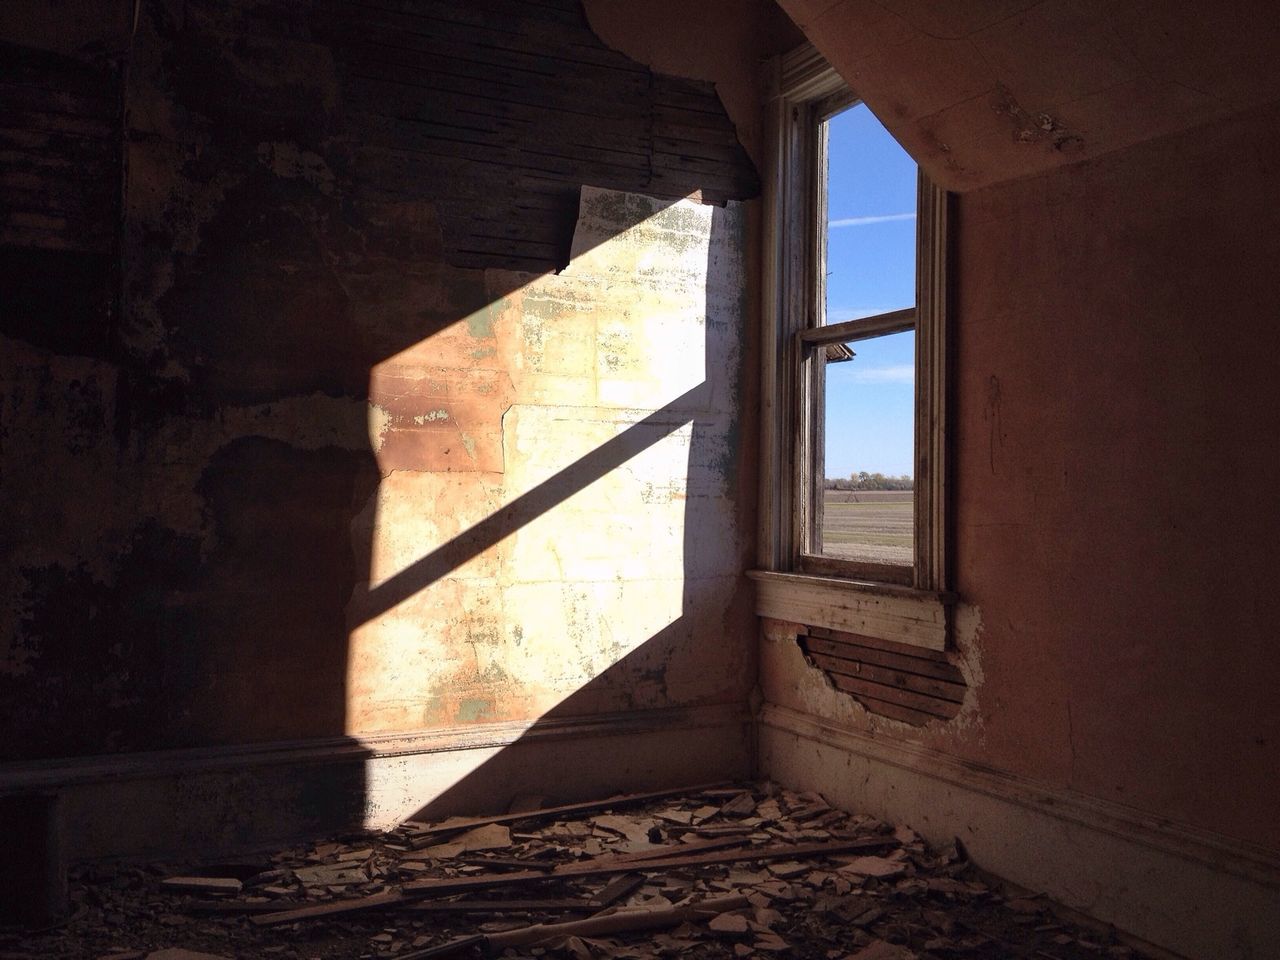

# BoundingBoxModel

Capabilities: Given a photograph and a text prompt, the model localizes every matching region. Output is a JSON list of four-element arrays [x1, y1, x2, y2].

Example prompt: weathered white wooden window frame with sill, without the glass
[[750, 45, 956, 649]]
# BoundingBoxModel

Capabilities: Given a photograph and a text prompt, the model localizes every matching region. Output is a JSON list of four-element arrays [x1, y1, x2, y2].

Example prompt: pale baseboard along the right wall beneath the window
[[759, 704, 1280, 960]]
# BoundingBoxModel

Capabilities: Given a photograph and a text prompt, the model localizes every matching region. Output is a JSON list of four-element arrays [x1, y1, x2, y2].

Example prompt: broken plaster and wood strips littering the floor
[[0, 783, 1138, 960]]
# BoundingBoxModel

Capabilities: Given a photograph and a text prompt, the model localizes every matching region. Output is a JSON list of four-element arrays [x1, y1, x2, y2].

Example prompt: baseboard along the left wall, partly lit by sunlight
[[0, 704, 751, 859]]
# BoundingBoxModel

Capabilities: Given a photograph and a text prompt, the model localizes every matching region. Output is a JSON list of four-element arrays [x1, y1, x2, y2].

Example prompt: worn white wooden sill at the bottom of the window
[[746, 570, 956, 650]]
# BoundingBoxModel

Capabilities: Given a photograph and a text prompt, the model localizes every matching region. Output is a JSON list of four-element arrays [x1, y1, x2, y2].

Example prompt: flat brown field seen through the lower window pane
[[822, 490, 915, 564]]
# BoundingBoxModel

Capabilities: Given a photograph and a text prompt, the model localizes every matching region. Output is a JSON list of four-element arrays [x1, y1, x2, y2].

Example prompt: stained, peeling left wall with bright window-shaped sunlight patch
[[0, 0, 759, 844]]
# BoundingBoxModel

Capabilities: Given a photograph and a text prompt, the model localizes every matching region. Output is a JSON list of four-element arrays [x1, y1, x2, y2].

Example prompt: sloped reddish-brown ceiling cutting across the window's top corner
[[780, 0, 1280, 191]]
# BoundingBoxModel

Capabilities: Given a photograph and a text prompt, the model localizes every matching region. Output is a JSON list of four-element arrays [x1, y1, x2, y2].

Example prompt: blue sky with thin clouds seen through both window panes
[[826, 104, 915, 477]]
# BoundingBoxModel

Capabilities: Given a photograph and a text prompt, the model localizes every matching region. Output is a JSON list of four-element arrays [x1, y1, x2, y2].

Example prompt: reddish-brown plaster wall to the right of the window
[[762, 92, 1280, 956]]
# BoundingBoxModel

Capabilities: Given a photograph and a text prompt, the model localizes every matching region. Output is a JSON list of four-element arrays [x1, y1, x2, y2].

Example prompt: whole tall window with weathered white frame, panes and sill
[[753, 46, 954, 649]]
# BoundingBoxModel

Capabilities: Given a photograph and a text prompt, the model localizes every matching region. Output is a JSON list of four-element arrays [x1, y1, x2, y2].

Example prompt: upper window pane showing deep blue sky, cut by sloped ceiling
[[826, 104, 916, 324]]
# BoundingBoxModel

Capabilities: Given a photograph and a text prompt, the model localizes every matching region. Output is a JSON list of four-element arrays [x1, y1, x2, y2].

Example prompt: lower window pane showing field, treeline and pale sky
[[813, 330, 915, 566]]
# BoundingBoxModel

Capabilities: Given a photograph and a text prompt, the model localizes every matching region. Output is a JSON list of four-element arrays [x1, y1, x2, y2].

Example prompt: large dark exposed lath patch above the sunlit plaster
[[323, 0, 759, 271]]
